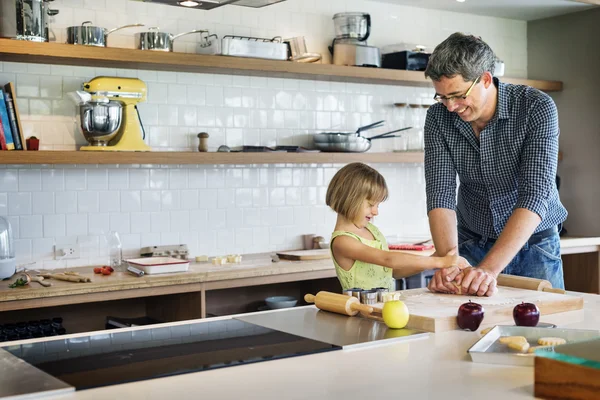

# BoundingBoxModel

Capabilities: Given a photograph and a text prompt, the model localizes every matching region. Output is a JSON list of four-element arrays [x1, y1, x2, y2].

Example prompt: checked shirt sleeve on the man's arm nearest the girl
[[424, 107, 456, 214]]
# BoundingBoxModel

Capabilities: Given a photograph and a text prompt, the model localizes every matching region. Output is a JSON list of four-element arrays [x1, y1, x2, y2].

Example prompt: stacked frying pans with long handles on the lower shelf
[[313, 127, 412, 153]]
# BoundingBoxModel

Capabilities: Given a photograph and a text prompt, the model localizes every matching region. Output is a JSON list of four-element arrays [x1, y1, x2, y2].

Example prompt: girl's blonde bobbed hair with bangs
[[325, 163, 389, 221]]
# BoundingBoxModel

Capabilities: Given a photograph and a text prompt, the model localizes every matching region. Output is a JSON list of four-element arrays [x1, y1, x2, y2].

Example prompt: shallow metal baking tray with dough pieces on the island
[[468, 325, 600, 367]]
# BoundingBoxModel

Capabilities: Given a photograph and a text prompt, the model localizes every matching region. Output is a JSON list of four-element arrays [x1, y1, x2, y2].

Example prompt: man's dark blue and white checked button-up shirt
[[425, 78, 567, 238]]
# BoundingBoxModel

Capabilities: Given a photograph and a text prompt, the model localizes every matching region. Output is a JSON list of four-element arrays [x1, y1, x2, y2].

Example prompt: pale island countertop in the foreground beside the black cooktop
[[7, 294, 600, 400]]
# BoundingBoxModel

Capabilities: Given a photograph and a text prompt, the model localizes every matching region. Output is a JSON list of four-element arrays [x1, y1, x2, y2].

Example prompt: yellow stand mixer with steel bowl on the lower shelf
[[77, 76, 152, 151]]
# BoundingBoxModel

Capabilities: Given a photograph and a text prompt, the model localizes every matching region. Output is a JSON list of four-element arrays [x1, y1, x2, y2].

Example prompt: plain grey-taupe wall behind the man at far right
[[529, 9, 600, 236]]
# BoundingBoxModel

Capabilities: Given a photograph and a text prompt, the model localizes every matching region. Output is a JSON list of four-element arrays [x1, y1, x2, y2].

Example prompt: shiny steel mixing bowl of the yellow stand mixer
[[79, 101, 123, 146]]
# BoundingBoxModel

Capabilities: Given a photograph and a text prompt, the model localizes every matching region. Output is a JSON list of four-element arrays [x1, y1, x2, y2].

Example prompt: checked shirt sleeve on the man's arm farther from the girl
[[515, 95, 559, 220]]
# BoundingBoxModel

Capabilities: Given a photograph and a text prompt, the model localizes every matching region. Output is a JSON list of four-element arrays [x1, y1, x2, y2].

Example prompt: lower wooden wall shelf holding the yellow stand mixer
[[0, 150, 423, 165]]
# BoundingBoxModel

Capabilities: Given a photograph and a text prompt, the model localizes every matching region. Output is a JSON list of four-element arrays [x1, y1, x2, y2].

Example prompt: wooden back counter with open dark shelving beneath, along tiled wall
[[0, 238, 600, 332]]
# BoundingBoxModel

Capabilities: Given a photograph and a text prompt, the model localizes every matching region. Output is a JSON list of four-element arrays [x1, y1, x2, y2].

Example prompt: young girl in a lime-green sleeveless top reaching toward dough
[[326, 163, 469, 290]]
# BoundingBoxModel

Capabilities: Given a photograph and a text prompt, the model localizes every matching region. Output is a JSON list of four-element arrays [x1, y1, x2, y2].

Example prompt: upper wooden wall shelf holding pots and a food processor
[[0, 39, 562, 92]]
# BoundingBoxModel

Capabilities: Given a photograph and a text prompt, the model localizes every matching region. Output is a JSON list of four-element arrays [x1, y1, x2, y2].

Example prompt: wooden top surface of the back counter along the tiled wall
[[0, 237, 600, 303]]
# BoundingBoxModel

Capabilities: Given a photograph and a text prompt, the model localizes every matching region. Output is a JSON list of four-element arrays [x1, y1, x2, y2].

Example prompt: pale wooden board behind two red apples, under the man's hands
[[361, 286, 583, 332]]
